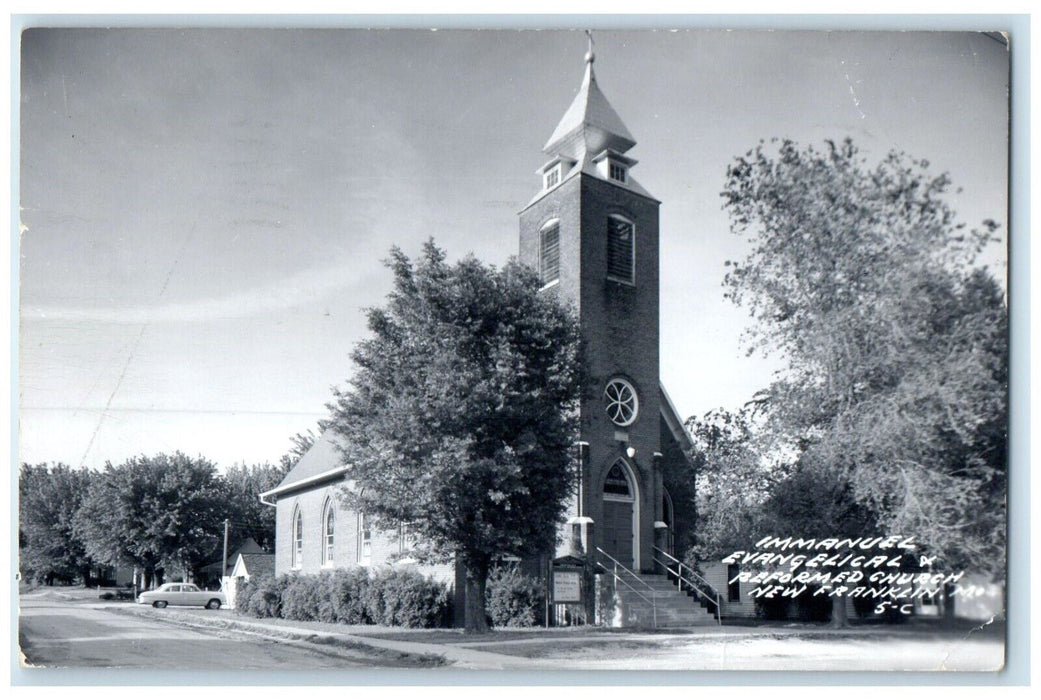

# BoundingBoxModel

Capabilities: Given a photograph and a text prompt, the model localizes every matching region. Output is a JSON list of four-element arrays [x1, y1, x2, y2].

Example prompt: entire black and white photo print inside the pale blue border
[[11, 23, 1011, 684]]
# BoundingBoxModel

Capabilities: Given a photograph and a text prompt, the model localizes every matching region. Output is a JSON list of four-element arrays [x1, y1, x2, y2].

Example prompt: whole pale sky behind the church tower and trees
[[19, 29, 1008, 467]]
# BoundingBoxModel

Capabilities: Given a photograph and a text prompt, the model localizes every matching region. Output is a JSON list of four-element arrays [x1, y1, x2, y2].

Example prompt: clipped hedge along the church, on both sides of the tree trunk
[[235, 566, 544, 627]]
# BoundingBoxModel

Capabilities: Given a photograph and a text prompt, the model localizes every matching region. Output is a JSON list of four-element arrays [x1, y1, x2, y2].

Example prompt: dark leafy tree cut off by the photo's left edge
[[18, 464, 93, 585]]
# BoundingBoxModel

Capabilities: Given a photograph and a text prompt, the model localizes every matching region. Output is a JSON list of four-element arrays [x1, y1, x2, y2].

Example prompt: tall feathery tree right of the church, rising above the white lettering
[[722, 140, 1008, 572]]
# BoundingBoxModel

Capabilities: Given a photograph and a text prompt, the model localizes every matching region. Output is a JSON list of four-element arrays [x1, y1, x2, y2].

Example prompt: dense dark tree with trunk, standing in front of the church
[[331, 242, 580, 631]]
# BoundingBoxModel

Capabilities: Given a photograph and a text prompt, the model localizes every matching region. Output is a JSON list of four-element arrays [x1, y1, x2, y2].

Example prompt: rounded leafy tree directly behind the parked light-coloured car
[[75, 452, 227, 581]]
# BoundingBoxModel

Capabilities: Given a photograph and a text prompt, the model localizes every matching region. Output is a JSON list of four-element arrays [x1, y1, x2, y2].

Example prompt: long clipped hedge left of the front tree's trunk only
[[235, 568, 451, 627]]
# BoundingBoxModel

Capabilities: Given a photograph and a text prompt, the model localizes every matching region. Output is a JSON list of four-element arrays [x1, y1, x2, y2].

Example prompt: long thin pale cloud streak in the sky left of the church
[[21, 264, 368, 324]]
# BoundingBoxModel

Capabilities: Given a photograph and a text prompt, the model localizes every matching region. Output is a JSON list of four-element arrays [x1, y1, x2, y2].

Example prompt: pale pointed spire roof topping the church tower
[[542, 53, 636, 158]]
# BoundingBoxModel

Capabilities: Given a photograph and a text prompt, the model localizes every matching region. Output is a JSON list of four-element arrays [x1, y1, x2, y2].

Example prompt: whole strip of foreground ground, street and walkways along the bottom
[[19, 589, 1005, 672]]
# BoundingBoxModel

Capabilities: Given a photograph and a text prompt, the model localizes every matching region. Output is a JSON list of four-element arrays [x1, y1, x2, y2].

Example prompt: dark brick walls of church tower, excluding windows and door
[[521, 175, 662, 571]]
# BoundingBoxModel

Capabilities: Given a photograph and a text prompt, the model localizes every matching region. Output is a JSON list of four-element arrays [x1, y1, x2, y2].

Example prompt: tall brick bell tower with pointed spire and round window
[[521, 41, 665, 572]]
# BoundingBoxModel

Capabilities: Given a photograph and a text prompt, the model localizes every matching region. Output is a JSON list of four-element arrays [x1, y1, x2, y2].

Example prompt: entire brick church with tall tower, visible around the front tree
[[261, 46, 694, 625]]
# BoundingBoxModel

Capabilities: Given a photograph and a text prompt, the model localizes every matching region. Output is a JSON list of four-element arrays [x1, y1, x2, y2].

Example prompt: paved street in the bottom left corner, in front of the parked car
[[18, 591, 412, 670]]
